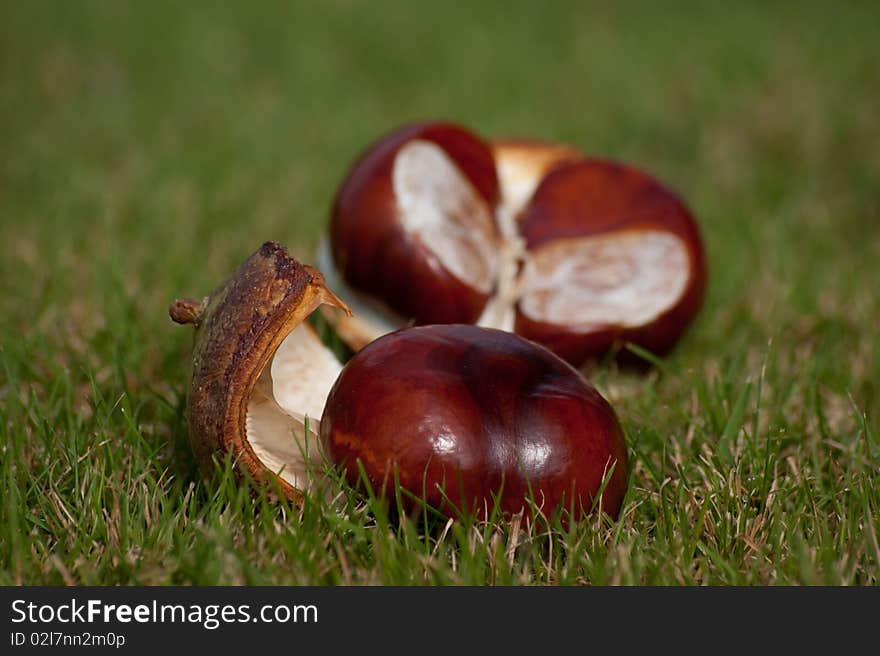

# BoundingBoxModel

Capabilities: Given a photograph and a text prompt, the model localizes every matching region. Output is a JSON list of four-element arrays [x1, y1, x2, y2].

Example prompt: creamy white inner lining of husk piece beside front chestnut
[[245, 324, 342, 490]]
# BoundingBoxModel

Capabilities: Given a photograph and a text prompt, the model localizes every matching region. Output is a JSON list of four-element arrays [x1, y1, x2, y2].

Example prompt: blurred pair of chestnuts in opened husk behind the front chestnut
[[318, 123, 706, 366]]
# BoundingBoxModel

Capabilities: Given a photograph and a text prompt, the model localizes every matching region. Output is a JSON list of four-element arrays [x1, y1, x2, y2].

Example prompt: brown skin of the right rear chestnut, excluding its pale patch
[[515, 159, 706, 364]]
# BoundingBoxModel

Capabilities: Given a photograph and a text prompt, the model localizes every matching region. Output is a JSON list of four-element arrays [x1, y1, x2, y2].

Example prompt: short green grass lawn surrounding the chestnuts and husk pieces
[[0, 1, 880, 585]]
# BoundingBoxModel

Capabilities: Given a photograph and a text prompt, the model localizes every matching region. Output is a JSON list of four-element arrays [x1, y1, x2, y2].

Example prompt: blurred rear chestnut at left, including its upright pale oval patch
[[330, 123, 499, 323]]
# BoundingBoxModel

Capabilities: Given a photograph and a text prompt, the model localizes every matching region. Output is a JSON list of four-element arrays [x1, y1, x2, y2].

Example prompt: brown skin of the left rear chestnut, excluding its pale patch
[[330, 122, 499, 324]]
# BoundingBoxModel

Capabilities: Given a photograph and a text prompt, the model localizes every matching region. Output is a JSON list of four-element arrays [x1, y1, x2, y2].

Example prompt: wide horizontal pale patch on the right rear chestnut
[[520, 230, 690, 331]]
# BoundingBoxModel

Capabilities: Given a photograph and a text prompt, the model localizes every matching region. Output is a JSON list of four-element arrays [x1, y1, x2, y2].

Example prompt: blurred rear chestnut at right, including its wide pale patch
[[515, 159, 706, 362]]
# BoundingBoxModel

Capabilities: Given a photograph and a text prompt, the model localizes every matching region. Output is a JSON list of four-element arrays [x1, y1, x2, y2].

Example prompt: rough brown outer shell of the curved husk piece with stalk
[[169, 241, 349, 503]]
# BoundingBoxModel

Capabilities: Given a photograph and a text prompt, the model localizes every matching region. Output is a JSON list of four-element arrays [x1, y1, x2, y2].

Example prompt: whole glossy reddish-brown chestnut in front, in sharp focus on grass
[[321, 325, 628, 519]]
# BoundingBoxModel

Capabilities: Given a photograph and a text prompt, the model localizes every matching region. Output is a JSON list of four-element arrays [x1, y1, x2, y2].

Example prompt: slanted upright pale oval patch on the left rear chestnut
[[392, 139, 497, 294]]
